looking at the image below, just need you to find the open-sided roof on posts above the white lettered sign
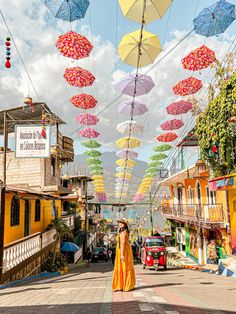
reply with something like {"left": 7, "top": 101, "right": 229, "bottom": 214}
{"left": 0, "top": 103, "right": 65, "bottom": 135}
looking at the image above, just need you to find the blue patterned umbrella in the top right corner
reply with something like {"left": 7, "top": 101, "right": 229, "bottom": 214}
{"left": 193, "top": 0, "right": 235, "bottom": 37}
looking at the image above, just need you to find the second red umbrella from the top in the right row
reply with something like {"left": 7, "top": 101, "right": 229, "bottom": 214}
{"left": 173, "top": 76, "right": 202, "bottom": 96}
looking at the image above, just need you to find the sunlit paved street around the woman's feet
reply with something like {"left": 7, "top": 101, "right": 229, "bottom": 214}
{"left": 0, "top": 262, "right": 236, "bottom": 314}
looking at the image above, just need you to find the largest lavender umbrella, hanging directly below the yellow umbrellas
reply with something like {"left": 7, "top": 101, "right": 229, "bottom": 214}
{"left": 116, "top": 74, "right": 155, "bottom": 96}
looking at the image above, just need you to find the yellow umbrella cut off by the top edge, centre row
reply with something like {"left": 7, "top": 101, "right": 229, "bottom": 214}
{"left": 119, "top": 0, "right": 173, "bottom": 23}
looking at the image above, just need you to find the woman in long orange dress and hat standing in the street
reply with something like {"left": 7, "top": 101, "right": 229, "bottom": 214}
{"left": 112, "top": 218, "right": 135, "bottom": 291}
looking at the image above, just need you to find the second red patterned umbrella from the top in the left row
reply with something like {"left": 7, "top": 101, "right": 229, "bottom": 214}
{"left": 64, "top": 67, "right": 95, "bottom": 87}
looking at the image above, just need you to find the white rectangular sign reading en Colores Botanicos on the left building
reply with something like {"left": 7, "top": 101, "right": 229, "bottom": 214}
{"left": 15, "top": 125, "right": 50, "bottom": 158}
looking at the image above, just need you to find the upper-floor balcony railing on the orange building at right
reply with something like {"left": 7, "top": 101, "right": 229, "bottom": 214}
{"left": 159, "top": 204, "right": 224, "bottom": 225}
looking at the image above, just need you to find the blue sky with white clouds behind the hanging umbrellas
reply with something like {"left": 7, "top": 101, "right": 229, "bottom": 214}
{"left": 0, "top": 0, "right": 236, "bottom": 169}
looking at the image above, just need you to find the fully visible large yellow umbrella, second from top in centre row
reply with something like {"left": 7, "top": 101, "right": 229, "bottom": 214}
{"left": 117, "top": 30, "right": 161, "bottom": 67}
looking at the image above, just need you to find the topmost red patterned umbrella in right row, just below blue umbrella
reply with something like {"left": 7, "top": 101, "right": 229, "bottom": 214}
{"left": 181, "top": 45, "right": 216, "bottom": 71}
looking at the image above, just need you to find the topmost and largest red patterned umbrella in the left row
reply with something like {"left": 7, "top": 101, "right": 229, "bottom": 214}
{"left": 56, "top": 31, "right": 93, "bottom": 60}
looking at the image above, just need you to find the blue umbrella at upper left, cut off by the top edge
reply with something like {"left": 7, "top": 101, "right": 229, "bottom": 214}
{"left": 44, "top": 0, "right": 89, "bottom": 22}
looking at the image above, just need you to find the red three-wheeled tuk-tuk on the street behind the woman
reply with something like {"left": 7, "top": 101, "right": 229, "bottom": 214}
{"left": 141, "top": 236, "right": 167, "bottom": 270}
